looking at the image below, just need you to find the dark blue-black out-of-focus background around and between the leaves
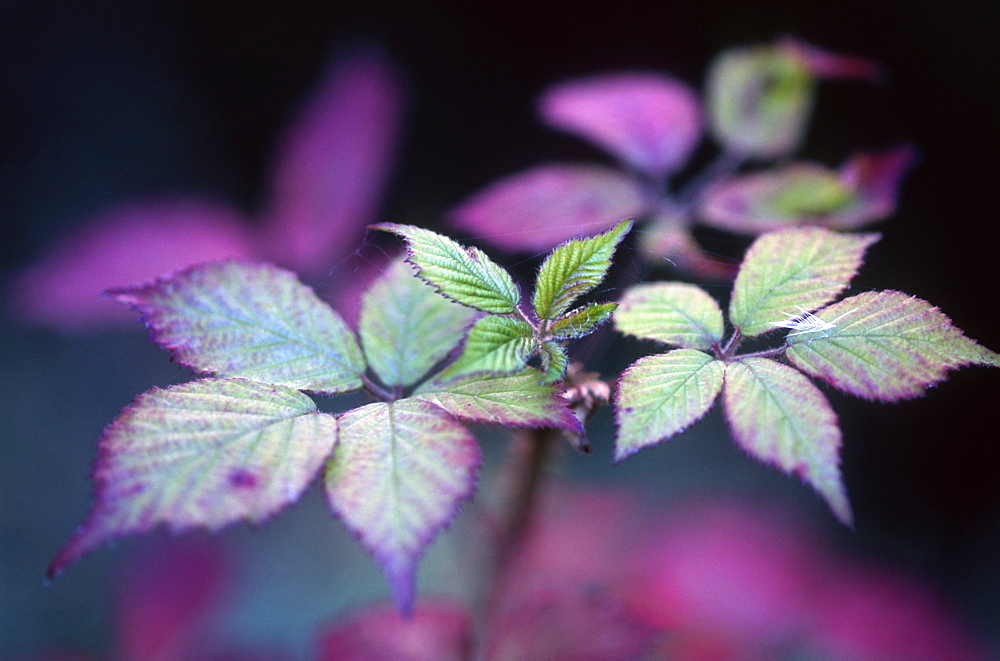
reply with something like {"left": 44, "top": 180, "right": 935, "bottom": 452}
{"left": 0, "top": 0, "right": 1000, "bottom": 658}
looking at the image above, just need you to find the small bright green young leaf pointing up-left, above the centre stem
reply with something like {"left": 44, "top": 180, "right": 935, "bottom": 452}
{"left": 372, "top": 223, "right": 521, "bottom": 314}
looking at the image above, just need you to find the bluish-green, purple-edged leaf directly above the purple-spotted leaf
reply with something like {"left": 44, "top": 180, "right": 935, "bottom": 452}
{"left": 110, "top": 261, "right": 365, "bottom": 394}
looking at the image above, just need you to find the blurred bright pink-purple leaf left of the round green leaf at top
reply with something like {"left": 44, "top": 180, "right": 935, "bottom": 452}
{"left": 538, "top": 72, "right": 702, "bottom": 177}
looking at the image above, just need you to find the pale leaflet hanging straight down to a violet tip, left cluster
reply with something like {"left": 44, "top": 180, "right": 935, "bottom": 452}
{"left": 325, "top": 399, "right": 479, "bottom": 613}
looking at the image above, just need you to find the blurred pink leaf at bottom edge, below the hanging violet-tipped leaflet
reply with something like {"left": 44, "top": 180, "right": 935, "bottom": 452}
{"left": 317, "top": 599, "right": 472, "bottom": 661}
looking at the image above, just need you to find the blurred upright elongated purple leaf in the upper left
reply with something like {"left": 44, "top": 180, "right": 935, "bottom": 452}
{"left": 260, "top": 50, "right": 403, "bottom": 273}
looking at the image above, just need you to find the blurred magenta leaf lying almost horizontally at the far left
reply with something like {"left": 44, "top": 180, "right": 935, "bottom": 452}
{"left": 10, "top": 199, "right": 252, "bottom": 331}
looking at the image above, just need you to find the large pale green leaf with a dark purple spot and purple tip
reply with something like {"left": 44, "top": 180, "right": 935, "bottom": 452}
{"left": 49, "top": 379, "right": 337, "bottom": 576}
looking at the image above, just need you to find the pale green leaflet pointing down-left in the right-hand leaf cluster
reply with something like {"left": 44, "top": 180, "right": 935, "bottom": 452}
{"left": 615, "top": 349, "right": 725, "bottom": 462}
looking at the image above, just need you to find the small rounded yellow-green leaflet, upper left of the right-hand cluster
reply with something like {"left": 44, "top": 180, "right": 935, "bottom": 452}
{"left": 614, "top": 282, "right": 723, "bottom": 351}
